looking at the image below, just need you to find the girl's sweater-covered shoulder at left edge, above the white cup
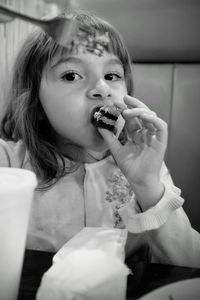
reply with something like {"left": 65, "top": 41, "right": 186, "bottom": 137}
{"left": 0, "top": 139, "right": 27, "bottom": 168}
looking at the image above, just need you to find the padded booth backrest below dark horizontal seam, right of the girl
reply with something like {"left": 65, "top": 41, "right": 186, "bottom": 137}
{"left": 132, "top": 62, "right": 200, "bottom": 232}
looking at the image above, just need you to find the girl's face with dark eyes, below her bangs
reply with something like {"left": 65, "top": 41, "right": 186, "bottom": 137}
{"left": 39, "top": 50, "right": 127, "bottom": 152}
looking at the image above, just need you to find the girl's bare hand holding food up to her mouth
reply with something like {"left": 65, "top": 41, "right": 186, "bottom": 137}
{"left": 99, "top": 96, "right": 168, "bottom": 210}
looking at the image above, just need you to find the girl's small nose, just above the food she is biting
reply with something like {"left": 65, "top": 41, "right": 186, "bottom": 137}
{"left": 88, "top": 79, "right": 111, "bottom": 100}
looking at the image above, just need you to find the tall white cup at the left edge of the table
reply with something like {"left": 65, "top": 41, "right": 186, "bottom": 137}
{"left": 0, "top": 168, "right": 37, "bottom": 300}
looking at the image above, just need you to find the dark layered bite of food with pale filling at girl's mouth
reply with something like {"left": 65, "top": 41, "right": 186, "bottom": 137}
{"left": 91, "top": 105, "right": 123, "bottom": 133}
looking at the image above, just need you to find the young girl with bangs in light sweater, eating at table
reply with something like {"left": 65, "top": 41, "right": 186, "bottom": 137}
{"left": 0, "top": 13, "right": 200, "bottom": 266}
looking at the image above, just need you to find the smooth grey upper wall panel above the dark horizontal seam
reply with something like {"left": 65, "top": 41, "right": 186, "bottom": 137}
{"left": 73, "top": 0, "right": 200, "bottom": 63}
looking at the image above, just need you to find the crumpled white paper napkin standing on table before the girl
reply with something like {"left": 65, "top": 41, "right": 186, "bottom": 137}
{"left": 37, "top": 228, "right": 130, "bottom": 300}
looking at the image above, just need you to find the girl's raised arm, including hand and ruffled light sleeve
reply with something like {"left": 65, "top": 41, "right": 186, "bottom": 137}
{"left": 99, "top": 96, "right": 200, "bottom": 267}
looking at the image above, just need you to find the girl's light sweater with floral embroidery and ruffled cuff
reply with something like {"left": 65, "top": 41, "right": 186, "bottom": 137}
{"left": 0, "top": 140, "right": 200, "bottom": 267}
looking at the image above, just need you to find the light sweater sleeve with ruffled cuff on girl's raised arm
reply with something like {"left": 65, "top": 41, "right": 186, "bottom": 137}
{"left": 119, "top": 165, "right": 200, "bottom": 267}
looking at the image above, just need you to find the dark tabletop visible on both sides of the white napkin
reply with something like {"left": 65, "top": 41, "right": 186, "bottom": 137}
{"left": 18, "top": 250, "right": 200, "bottom": 300}
